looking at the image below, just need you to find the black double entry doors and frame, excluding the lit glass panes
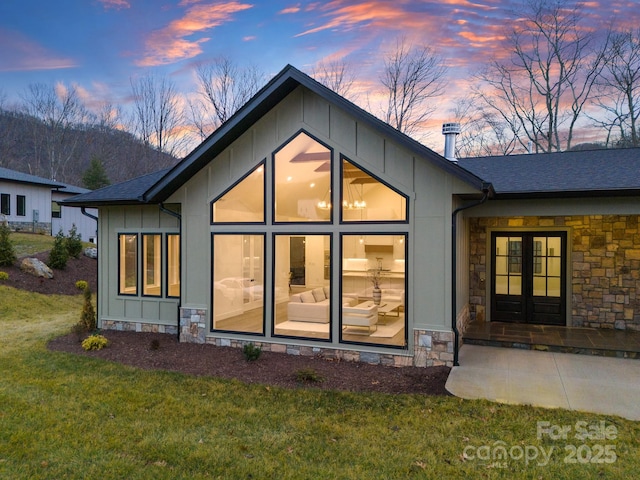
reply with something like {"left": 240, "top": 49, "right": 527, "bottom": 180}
{"left": 487, "top": 230, "right": 569, "bottom": 326}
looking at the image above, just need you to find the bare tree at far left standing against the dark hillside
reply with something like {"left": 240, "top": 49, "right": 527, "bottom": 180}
{"left": 22, "top": 83, "right": 87, "bottom": 181}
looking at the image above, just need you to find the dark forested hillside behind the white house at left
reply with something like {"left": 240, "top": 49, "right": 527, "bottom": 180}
{"left": 0, "top": 110, "right": 178, "bottom": 186}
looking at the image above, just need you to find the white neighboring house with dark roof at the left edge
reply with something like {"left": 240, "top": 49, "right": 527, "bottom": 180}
{"left": 0, "top": 167, "right": 97, "bottom": 242}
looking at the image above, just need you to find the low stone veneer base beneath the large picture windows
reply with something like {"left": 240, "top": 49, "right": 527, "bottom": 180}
{"left": 180, "top": 308, "right": 454, "bottom": 367}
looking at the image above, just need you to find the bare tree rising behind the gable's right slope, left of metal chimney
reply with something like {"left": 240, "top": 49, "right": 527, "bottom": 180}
{"left": 380, "top": 38, "right": 446, "bottom": 135}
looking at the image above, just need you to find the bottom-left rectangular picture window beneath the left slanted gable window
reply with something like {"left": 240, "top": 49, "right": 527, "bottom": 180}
{"left": 213, "top": 234, "right": 264, "bottom": 334}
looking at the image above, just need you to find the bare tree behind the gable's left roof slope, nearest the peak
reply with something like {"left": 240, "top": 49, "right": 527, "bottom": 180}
{"left": 189, "top": 57, "right": 265, "bottom": 140}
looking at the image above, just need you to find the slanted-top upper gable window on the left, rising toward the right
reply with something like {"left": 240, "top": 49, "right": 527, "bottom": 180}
{"left": 211, "top": 163, "right": 264, "bottom": 223}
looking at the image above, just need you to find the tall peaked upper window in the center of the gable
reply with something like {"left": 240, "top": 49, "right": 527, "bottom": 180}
{"left": 274, "top": 132, "right": 332, "bottom": 222}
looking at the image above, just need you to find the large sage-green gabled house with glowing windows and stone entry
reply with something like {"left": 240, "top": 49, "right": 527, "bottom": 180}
{"left": 64, "top": 66, "right": 640, "bottom": 366}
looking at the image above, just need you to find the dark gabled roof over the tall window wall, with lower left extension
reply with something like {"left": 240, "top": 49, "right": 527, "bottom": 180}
{"left": 85, "top": 65, "right": 486, "bottom": 205}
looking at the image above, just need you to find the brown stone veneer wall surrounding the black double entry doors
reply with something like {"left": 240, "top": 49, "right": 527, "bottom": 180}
{"left": 469, "top": 215, "right": 640, "bottom": 331}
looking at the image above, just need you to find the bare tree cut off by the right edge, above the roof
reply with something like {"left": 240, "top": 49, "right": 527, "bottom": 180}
{"left": 594, "top": 29, "right": 640, "bottom": 147}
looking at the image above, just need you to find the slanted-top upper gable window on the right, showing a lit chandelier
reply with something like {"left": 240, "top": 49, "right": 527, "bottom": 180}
{"left": 341, "top": 158, "right": 407, "bottom": 222}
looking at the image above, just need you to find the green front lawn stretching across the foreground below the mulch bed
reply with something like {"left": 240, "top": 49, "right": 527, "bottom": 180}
{"left": 0, "top": 286, "right": 640, "bottom": 479}
